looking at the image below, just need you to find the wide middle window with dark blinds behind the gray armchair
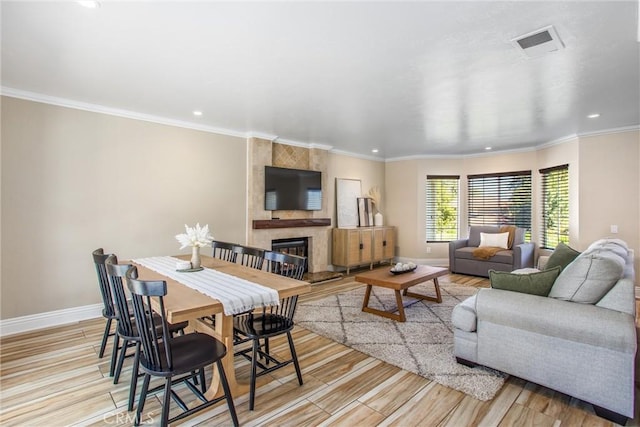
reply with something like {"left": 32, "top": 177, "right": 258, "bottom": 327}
{"left": 467, "top": 171, "right": 531, "bottom": 237}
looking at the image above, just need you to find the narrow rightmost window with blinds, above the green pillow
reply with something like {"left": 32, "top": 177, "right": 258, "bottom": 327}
{"left": 540, "top": 165, "right": 569, "bottom": 249}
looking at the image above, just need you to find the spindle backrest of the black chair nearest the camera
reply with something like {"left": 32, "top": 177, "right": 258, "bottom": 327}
{"left": 126, "top": 266, "right": 173, "bottom": 372}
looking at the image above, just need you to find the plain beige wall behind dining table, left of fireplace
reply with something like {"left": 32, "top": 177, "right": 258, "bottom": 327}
{"left": 1, "top": 97, "right": 247, "bottom": 319}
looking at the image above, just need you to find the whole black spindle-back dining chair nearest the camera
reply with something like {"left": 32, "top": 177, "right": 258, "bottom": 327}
{"left": 126, "top": 266, "right": 238, "bottom": 426}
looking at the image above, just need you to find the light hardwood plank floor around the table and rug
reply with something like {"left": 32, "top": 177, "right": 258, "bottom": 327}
{"left": 0, "top": 272, "right": 638, "bottom": 427}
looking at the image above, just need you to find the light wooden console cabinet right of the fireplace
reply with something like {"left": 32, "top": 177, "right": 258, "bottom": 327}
{"left": 331, "top": 227, "right": 396, "bottom": 274}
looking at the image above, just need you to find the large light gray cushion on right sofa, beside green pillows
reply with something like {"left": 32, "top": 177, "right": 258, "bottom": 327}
{"left": 549, "top": 251, "right": 625, "bottom": 304}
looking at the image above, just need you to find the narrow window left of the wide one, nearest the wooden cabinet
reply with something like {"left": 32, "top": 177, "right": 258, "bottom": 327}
{"left": 426, "top": 175, "right": 460, "bottom": 242}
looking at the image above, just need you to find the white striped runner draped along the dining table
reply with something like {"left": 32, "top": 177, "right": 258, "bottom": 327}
{"left": 133, "top": 256, "right": 280, "bottom": 316}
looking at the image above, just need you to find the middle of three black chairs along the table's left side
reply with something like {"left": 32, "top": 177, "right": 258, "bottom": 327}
{"left": 105, "top": 255, "right": 189, "bottom": 411}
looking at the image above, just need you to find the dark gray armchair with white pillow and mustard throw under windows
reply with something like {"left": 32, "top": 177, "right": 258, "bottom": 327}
{"left": 449, "top": 226, "right": 535, "bottom": 277}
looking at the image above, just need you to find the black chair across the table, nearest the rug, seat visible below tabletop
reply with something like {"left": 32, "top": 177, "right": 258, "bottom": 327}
{"left": 234, "top": 251, "right": 306, "bottom": 410}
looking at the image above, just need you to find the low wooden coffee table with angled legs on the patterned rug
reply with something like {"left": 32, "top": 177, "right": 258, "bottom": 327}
{"left": 355, "top": 265, "right": 449, "bottom": 322}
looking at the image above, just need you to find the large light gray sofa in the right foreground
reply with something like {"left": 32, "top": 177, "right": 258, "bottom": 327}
{"left": 452, "top": 240, "right": 637, "bottom": 425}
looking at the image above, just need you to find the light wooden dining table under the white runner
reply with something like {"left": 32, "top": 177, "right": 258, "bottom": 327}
{"left": 132, "top": 255, "right": 311, "bottom": 399}
